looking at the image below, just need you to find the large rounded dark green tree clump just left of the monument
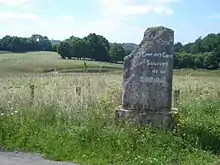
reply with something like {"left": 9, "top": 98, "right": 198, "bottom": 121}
{"left": 53, "top": 33, "right": 128, "bottom": 62}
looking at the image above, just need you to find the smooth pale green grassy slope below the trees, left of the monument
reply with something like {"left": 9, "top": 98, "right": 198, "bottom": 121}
{"left": 0, "top": 52, "right": 122, "bottom": 74}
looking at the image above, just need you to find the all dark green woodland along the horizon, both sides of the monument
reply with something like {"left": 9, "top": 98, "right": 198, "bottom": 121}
{"left": 0, "top": 33, "right": 220, "bottom": 69}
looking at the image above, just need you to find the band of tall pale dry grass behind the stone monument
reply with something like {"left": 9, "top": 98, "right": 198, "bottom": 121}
{"left": 0, "top": 73, "right": 220, "bottom": 106}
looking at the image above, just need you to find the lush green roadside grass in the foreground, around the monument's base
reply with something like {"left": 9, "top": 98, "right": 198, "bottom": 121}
{"left": 0, "top": 98, "right": 220, "bottom": 165}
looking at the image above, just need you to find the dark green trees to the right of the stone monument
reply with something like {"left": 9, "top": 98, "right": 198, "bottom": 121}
{"left": 174, "top": 33, "right": 220, "bottom": 69}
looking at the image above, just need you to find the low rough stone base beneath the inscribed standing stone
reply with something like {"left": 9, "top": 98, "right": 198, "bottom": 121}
{"left": 115, "top": 109, "right": 173, "bottom": 129}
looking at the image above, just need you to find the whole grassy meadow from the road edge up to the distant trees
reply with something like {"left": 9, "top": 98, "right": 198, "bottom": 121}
{"left": 0, "top": 52, "right": 220, "bottom": 165}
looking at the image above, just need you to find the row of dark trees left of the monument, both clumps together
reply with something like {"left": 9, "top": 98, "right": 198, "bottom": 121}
{"left": 0, "top": 33, "right": 127, "bottom": 62}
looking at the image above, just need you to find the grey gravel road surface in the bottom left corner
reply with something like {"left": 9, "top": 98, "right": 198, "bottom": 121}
{"left": 0, "top": 152, "right": 79, "bottom": 165}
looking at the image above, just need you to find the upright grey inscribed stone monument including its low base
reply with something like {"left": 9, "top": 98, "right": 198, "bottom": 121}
{"left": 116, "top": 27, "right": 174, "bottom": 127}
